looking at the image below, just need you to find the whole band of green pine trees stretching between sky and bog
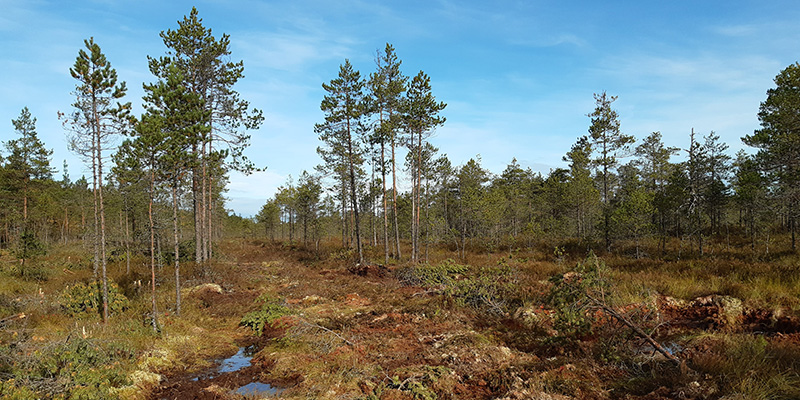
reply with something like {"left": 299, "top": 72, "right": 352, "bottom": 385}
{"left": 0, "top": 0, "right": 800, "bottom": 327}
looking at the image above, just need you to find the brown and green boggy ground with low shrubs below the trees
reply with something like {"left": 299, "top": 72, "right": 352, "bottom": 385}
{"left": 0, "top": 240, "right": 800, "bottom": 399}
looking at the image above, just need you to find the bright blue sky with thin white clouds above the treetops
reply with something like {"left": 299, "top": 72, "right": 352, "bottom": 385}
{"left": 0, "top": 0, "right": 800, "bottom": 215}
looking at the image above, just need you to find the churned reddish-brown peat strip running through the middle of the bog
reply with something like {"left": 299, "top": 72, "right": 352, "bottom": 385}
{"left": 150, "top": 242, "right": 800, "bottom": 400}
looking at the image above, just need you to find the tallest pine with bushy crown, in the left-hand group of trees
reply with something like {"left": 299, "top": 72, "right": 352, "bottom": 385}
{"left": 156, "top": 7, "right": 264, "bottom": 262}
